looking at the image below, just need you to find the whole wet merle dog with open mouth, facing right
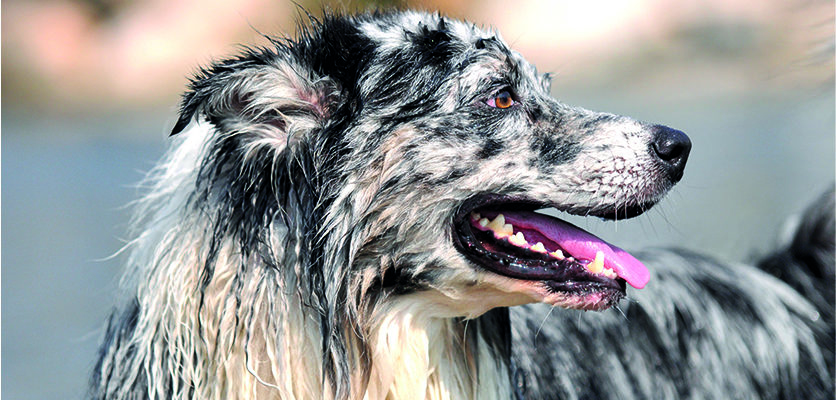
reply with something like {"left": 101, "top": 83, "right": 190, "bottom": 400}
{"left": 90, "top": 11, "right": 834, "bottom": 399}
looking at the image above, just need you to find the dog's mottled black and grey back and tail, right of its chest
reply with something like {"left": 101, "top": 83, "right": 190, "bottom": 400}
{"left": 511, "top": 189, "right": 836, "bottom": 400}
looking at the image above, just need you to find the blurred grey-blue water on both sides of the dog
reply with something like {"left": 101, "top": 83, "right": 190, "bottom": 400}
{"left": 2, "top": 86, "right": 835, "bottom": 399}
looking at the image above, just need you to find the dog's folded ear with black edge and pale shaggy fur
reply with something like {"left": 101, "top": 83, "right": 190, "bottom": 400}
{"left": 171, "top": 49, "right": 338, "bottom": 138}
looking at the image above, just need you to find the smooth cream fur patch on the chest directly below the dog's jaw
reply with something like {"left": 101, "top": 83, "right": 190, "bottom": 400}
{"left": 358, "top": 299, "right": 511, "bottom": 400}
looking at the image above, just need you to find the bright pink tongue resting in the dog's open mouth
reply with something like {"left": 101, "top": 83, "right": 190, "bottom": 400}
{"left": 496, "top": 211, "right": 650, "bottom": 289}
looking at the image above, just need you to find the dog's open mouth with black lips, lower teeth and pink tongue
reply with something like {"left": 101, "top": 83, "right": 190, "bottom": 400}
{"left": 454, "top": 199, "right": 649, "bottom": 305}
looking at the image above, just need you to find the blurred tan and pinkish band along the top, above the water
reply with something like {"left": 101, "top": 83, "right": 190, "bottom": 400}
{"left": 2, "top": 0, "right": 834, "bottom": 111}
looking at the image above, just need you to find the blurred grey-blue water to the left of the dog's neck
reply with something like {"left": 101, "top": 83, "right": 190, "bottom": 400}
{"left": 2, "top": 113, "right": 165, "bottom": 399}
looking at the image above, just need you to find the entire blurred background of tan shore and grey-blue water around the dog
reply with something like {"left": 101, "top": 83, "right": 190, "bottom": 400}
{"left": 2, "top": 0, "right": 836, "bottom": 399}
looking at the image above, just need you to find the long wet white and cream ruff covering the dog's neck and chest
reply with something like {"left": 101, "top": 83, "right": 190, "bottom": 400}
{"left": 93, "top": 125, "right": 511, "bottom": 399}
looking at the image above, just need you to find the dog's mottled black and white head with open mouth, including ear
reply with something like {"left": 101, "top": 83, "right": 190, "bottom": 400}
{"left": 174, "top": 12, "right": 691, "bottom": 317}
